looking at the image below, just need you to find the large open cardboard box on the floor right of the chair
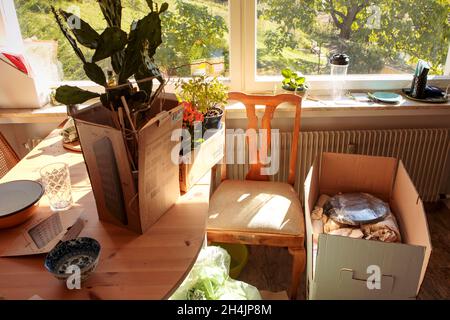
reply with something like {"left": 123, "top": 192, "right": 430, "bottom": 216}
{"left": 305, "top": 153, "right": 431, "bottom": 299}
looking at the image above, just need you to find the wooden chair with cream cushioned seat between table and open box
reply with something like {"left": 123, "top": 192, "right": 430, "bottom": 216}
{"left": 207, "top": 92, "right": 306, "bottom": 299}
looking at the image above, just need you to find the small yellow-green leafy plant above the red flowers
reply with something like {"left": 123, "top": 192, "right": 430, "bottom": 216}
{"left": 176, "top": 76, "right": 228, "bottom": 114}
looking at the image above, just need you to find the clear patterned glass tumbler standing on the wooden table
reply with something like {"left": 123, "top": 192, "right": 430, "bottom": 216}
{"left": 40, "top": 162, "right": 73, "bottom": 211}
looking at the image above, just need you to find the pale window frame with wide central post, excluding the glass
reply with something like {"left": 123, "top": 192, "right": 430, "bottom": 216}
{"left": 0, "top": 0, "right": 450, "bottom": 94}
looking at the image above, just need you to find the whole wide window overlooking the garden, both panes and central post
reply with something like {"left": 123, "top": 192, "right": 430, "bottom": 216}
{"left": 0, "top": 0, "right": 450, "bottom": 92}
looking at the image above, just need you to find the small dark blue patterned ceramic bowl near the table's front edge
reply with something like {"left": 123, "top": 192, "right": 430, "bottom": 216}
{"left": 44, "top": 237, "right": 100, "bottom": 281}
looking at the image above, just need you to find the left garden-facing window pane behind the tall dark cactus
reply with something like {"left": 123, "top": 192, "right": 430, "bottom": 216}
{"left": 14, "top": 0, "right": 229, "bottom": 80}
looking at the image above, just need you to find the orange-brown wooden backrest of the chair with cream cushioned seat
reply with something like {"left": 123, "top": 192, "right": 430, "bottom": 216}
{"left": 228, "top": 92, "right": 302, "bottom": 185}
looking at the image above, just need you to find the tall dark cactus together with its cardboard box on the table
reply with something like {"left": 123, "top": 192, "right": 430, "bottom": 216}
{"left": 52, "top": 0, "right": 183, "bottom": 233}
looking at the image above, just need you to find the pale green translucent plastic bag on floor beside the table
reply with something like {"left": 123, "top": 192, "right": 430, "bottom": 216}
{"left": 169, "top": 246, "right": 261, "bottom": 300}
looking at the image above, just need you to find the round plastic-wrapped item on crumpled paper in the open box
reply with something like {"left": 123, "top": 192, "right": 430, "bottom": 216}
{"left": 324, "top": 193, "right": 390, "bottom": 226}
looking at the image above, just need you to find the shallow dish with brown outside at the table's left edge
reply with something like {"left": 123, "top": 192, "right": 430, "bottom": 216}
{"left": 0, "top": 180, "right": 44, "bottom": 229}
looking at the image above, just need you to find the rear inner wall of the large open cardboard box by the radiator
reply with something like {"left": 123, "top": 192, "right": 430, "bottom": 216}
{"left": 320, "top": 153, "right": 397, "bottom": 201}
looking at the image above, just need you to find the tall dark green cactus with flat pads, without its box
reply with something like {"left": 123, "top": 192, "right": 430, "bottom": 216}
{"left": 51, "top": 0, "right": 168, "bottom": 107}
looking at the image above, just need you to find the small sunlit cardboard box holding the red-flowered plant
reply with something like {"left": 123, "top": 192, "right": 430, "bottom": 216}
{"left": 179, "top": 122, "right": 225, "bottom": 192}
